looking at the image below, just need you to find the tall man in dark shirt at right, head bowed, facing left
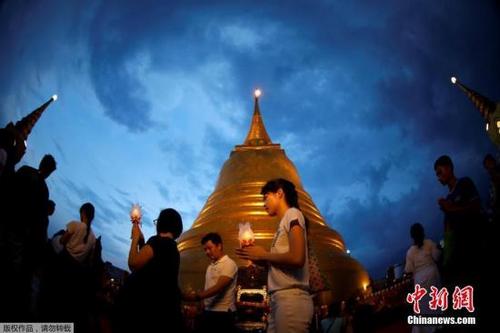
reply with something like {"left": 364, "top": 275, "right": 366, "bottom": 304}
{"left": 434, "top": 155, "right": 483, "bottom": 290}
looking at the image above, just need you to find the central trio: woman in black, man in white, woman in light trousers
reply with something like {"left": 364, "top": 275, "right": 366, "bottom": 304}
{"left": 113, "top": 179, "right": 313, "bottom": 332}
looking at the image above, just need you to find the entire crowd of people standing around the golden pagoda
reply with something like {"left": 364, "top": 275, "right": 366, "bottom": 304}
{"left": 0, "top": 128, "right": 500, "bottom": 333}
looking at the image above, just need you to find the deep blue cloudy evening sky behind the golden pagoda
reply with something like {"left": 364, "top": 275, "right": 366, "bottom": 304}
{"left": 0, "top": 0, "right": 500, "bottom": 278}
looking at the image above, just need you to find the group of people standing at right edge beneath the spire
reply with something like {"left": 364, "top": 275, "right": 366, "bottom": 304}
{"left": 405, "top": 154, "right": 500, "bottom": 332}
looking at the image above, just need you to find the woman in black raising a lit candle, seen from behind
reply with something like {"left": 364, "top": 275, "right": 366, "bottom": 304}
{"left": 114, "top": 208, "right": 183, "bottom": 332}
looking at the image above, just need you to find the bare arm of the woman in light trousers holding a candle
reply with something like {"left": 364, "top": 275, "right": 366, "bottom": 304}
{"left": 236, "top": 220, "right": 306, "bottom": 268}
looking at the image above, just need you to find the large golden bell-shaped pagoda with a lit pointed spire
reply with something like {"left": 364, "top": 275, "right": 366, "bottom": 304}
{"left": 178, "top": 90, "right": 370, "bottom": 303}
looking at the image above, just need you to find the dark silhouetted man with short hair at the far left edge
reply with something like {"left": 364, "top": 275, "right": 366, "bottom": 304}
{"left": 0, "top": 155, "right": 56, "bottom": 320}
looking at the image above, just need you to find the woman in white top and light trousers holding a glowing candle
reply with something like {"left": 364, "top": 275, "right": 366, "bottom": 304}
{"left": 236, "top": 178, "right": 314, "bottom": 333}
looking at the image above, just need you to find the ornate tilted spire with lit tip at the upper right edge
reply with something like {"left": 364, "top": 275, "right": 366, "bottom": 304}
{"left": 451, "top": 76, "right": 500, "bottom": 147}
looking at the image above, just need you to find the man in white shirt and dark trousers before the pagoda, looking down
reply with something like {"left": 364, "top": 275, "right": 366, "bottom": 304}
{"left": 187, "top": 232, "right": 238, "bottom": 332}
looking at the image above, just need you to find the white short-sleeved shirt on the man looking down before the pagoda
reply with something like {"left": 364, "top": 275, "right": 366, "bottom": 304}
{"left": 204, "top": 254, "right": 238, "bottom": 312}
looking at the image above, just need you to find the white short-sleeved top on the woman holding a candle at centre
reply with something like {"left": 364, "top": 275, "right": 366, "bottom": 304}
{"left": 267, "top": 208, "right": 309, "bottom": 292}
